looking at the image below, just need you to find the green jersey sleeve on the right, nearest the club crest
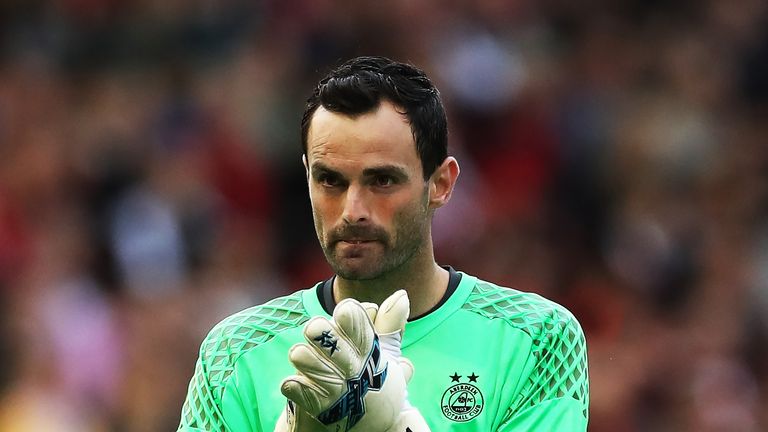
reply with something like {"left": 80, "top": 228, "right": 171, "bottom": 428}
{"left": 497, "top": 308, "right": 589, "bottom": 432}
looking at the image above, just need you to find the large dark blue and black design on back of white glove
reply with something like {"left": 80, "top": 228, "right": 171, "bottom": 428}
{"left": 317, "top": 336, "right": 387, "bottom": 430}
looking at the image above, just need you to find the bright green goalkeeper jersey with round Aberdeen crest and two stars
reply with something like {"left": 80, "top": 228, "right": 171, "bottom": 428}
{"left": 179, "top": 269, "right": 589, "bottom": 432}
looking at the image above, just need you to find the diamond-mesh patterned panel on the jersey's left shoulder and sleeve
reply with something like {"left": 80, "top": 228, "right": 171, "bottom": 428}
{"left": 179, "top": 292, "right": 309, "bottom": 432}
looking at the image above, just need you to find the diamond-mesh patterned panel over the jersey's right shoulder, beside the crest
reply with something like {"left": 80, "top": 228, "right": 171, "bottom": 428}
{"left": 463, "top": 281, "right": 589, "bottom": 418}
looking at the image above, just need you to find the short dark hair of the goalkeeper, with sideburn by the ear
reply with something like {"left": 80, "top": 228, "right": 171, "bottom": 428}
{"left": 301, "top": 57, "right": 448, "bottom": 179}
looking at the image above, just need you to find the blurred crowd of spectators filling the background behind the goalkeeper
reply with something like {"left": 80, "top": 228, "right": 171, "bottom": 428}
{"left": 0, "top": 0, "right": 768, "bottom": 432}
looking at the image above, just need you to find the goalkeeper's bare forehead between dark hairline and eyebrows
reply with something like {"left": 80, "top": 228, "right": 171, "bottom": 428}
{"left": 307, "top": 101, "right": 421, "bottom": 169}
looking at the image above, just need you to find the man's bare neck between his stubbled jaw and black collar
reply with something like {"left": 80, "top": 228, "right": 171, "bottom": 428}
{"left": 333, "top": 243, "right": 448, "bottom": 317}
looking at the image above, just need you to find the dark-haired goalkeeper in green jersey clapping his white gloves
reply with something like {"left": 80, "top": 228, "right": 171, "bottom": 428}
{"left": 179, "top": 57, "right": 589, "bottom": 432}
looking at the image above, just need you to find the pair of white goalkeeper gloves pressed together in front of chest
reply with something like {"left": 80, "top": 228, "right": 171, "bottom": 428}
{"left": 275, "top": 290, "right": 429, "bottom": 432}
